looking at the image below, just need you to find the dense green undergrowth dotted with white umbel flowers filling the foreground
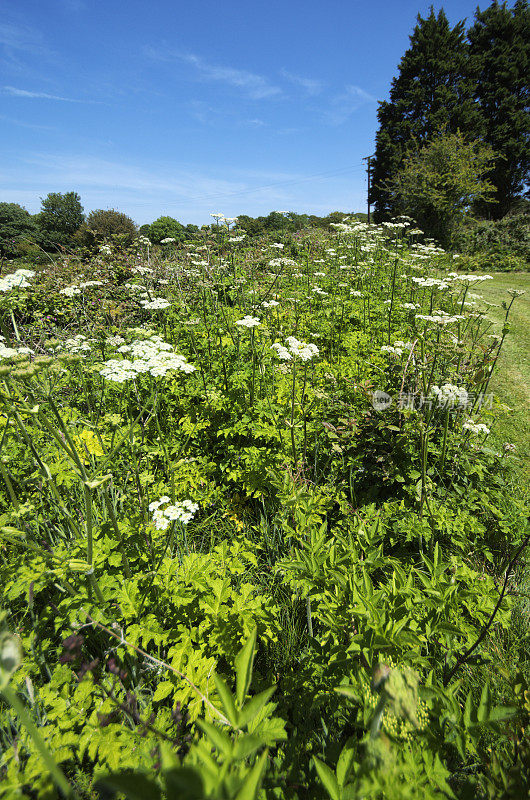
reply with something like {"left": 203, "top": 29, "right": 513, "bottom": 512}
{"left": 0, "top": 220, "right": 530, "bottom": 800}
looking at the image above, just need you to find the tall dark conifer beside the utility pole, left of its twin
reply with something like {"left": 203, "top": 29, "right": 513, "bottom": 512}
{"left": 370, "top": 6, "right": 482, "bottom": 220}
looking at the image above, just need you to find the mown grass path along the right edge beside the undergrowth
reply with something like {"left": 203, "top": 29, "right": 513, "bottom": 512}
{"left": 475, "top": 272, "right": 530, "bottom": 476}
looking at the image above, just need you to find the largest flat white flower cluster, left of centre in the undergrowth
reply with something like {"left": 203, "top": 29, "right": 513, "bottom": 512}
{"left": 99, "top": 336, "right": 195, "bottom": 383}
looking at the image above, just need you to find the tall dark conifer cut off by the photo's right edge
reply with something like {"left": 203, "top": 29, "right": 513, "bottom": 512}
{"left": 468, "top": 0, "right": 530, "bottom": 219}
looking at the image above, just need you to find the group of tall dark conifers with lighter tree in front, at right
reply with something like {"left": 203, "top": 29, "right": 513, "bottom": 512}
{"left": 369, "top": 0, "right": 530, "bottom": 236}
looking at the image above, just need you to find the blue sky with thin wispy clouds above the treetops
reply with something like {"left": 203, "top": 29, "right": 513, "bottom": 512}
{"left": 0, "top": 0, "right": 500, "bottom": 224}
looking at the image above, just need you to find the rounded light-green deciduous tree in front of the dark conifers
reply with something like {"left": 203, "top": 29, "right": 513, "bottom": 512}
{"left": 390, "top": 132, "right": 494, "bottom": 246}
